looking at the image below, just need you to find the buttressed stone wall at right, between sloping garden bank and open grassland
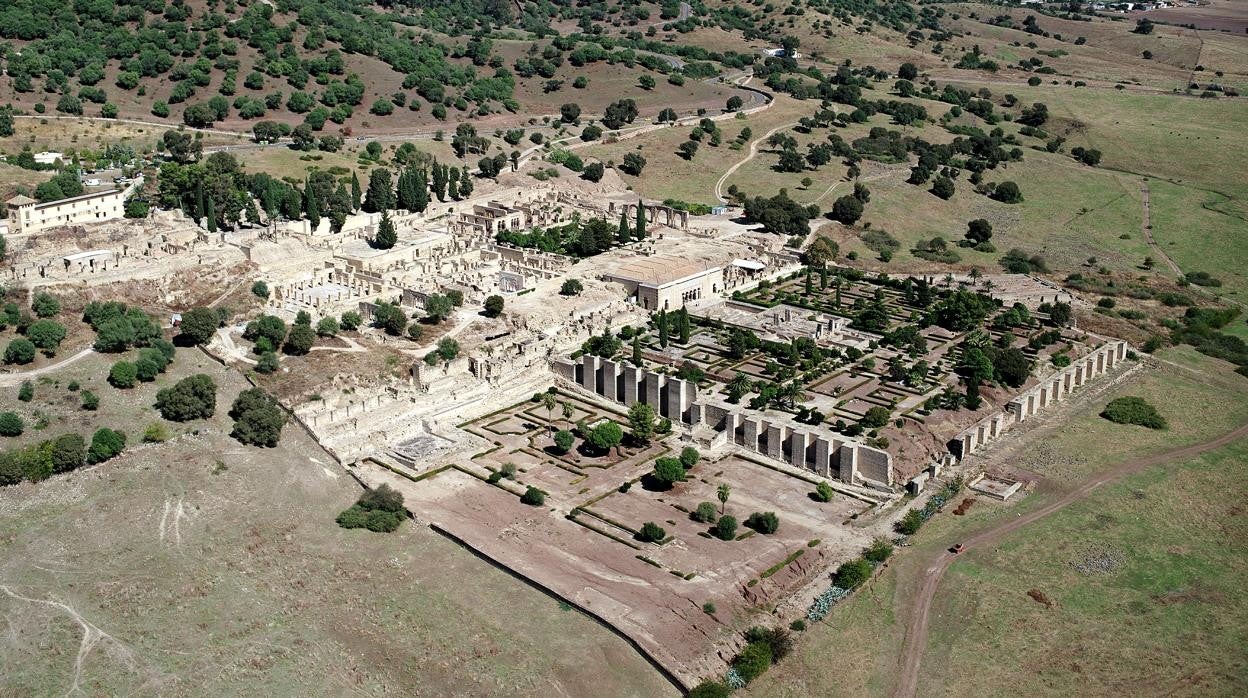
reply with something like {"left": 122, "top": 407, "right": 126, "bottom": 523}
{"left": 948, "top": 340, "right": 1128, "bottom": 458}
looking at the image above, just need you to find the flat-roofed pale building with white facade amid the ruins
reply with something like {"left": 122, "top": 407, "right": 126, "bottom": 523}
{"left": 603, "top": 256, "right": 724, "bottom": 311}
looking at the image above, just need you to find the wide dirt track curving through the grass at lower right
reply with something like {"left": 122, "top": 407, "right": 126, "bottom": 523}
{"left": 895, "top": 425, "right": 1248, "bottom": 698}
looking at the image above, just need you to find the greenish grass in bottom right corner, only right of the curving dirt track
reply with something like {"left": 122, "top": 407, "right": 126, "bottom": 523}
{"left": 920, "top": 441, "right": 1248, "bottom": 696}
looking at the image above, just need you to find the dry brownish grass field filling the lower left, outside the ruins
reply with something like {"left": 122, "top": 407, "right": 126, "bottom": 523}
{"left": 0, "top": 350, "right": 673, "bottom": 697}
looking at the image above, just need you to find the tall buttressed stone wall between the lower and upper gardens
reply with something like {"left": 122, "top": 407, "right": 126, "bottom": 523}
{"left": 553, "top": 355, "right": 894, "bottom": 487}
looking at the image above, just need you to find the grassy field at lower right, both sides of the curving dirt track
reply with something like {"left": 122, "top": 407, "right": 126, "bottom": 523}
{"left": 749, "top": 347, "right": 1248, "bottom": 696}
